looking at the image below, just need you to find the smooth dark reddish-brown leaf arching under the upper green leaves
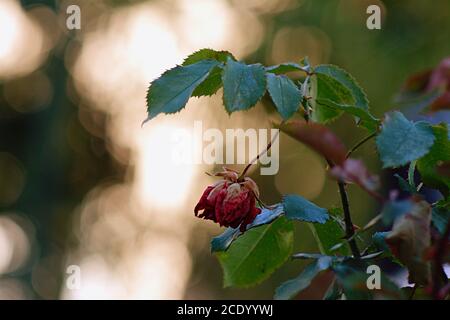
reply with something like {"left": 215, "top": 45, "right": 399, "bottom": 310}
{"left": 278, "top": 121, "right": 347, "bottom": 165}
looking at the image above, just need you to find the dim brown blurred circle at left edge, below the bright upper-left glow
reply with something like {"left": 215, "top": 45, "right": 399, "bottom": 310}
{"left": 3, "top": 71, "right": 53, "bottom": 113}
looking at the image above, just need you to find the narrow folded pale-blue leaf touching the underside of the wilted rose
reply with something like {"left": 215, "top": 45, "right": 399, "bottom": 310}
{"left": 211, "top": 203, "right": 284, "bottom": 252}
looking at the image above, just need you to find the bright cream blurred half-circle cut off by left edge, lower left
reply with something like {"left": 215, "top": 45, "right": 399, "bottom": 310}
{"left": 0, "top": 215, "right": 30, "bottom": 275}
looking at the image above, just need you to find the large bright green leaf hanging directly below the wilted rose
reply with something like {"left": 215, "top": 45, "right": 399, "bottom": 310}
{"left": 217, "top": 217, "right": 294, "bottom": 287}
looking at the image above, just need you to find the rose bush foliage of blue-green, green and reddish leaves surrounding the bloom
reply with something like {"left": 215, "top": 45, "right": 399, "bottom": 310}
{"left": 147, "top": 49, "right": 450, "bottom": 299}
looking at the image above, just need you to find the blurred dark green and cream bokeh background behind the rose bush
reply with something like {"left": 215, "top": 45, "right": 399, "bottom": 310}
{"left": 0, "top": 0, "right": 450, "bottom": 299}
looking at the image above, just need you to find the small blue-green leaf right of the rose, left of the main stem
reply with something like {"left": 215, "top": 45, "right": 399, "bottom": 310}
{"left": 283, "top": 194, "right": 329, "bottom": 223}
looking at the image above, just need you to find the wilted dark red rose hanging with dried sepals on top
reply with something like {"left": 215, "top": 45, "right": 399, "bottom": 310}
{"left": 194, "top": 169, "right": 261, "bottom": 232}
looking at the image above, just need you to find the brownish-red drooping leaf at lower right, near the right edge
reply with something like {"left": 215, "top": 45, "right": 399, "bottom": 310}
{"left": 385, "top": 200, "right": 431, "bottom": 285}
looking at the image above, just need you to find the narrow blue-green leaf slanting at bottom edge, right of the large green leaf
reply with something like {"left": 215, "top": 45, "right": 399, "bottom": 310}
{"left": 274, "top": 256, "right": 333, "bottom": 300}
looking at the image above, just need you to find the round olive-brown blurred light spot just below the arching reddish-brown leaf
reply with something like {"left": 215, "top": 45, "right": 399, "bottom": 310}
{"left": 275, "top": 135, "right": 326, "bottom": 199}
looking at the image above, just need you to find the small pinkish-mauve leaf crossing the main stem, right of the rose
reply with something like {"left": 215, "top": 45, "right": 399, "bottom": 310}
{"left": 331, "top": 159, "right": 379, "bottom": 191}
